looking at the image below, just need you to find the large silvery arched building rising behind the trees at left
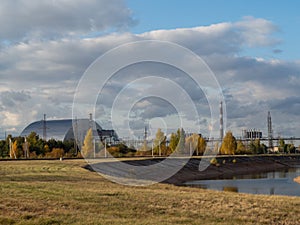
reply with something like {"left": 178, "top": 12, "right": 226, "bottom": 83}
{"left": 20, "top": 117, "right": 119, "bottom": 144}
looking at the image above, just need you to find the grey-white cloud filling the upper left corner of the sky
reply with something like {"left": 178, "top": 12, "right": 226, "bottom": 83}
{"left": 0, "top": 0, "right": 135, "bottom": 42}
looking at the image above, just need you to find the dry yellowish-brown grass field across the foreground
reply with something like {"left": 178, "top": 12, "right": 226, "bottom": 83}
{"left": 0, "top": 160, "right": 300, "bottom": 225}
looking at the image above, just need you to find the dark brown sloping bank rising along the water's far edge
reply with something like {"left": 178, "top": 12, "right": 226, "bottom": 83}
{"left": 164, "top": 156, "right": 300, "bottom": 185}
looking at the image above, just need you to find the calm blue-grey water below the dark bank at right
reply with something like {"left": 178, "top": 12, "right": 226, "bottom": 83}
{"left": 185, "top": 165, "right": 300, "bottom": 196}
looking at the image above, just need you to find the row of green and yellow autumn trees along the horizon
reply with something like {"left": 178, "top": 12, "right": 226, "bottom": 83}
{"left": 0, "top": 128, "right": 296, "bottom": 159}
